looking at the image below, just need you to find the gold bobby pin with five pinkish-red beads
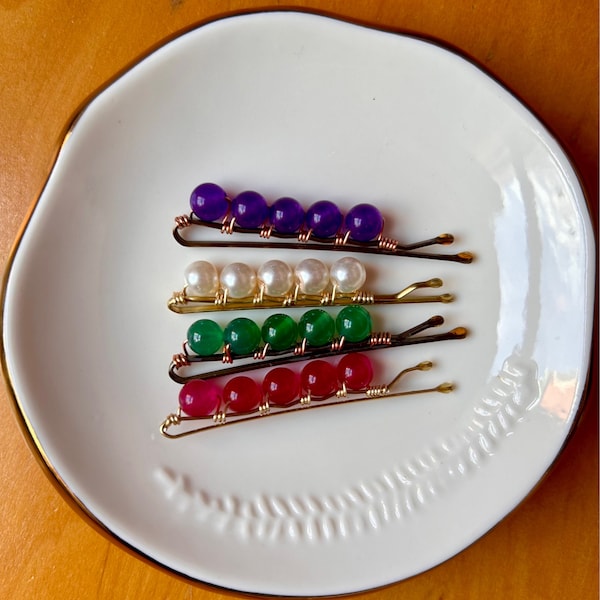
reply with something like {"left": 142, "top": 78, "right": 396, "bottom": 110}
{"left": 160, "top": 353, "right": 454, "bottom": 439}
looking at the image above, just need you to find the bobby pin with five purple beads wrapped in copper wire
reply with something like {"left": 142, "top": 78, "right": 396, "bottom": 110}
{"left": 173, "top": 183, "right": 473, "bottom": 263}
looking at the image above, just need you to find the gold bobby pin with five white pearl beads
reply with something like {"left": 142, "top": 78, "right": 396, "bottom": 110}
{"left": 167, "top": 256, "right": 454, "bottom": 313}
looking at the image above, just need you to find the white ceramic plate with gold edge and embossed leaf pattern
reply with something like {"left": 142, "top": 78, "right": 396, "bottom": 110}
{"left": 3, "top": 12, "right": 594, "bottom": 595}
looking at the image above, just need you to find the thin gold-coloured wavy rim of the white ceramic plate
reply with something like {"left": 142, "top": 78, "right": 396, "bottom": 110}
{"left": 0, "top": 7, "right": 598, "bottom": 598}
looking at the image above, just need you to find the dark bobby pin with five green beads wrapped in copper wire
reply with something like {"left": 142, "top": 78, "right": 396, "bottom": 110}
{"left": 169, "top": 306, "right": 467, "bottom": 383}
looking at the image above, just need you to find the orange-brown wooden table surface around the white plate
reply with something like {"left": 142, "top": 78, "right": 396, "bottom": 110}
{"left": 0, "top": 0, "right": 598, "bottom": 600}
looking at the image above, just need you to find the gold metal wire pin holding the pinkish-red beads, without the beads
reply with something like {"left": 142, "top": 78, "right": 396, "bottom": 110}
{"left": 160, "top": 361, "right": 455, "bottom": 439}
